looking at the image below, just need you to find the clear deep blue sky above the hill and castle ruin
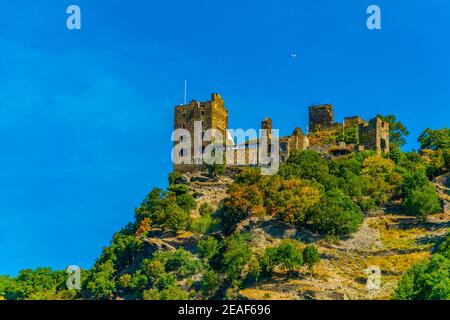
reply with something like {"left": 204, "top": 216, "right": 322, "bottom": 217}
{"left": 0, "top": 0, "right": 450, "bottom": 275}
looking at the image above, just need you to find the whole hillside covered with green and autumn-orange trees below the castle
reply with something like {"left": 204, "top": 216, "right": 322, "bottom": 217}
{"left": 0, "top": 140, "right": 450, "bottom": 300}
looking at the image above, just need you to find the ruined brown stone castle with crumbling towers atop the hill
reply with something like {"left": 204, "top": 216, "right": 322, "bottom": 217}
{"left": 173, "top": 93, "right": 389, "bottom": 171}
